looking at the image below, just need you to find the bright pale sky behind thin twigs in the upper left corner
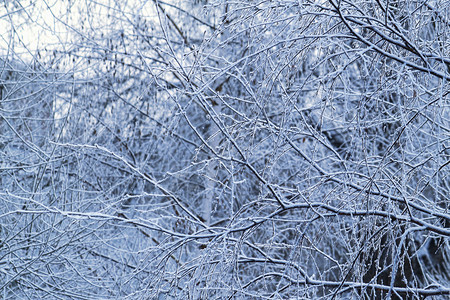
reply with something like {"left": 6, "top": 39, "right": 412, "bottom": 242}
{"left": 0, "top": 0, "right": 162, "bottom": 59}
